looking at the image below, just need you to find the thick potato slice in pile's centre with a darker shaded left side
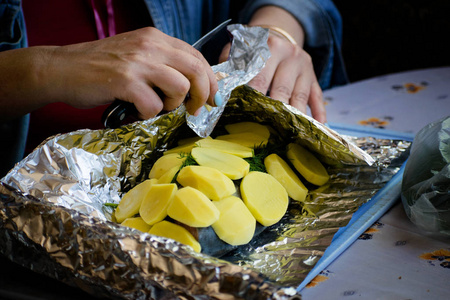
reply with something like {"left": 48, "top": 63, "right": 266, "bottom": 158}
{"left": 177, "top": 166, "right": 236, "bottom": 201}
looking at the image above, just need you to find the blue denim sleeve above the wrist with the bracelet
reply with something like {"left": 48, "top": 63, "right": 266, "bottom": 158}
{"left": 240, "top": 0, "right": 348, "bottom": 89}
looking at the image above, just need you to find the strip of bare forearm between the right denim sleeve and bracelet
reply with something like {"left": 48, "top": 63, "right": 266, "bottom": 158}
{"left": 248, "top": 6, "right": 305, "bottom": 47}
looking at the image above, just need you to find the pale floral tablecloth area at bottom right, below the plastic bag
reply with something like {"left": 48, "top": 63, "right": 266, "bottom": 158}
{"left": 302, "top": 203, "right": 450, "bottom": 300}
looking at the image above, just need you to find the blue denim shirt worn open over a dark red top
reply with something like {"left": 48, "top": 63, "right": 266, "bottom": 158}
{"left": 0, "top": 0, "right": 348, "bottom": 178}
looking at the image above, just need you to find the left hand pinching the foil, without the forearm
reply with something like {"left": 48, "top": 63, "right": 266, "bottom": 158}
{"left": 39, "top": 27, "right": 218, "bottom": 119}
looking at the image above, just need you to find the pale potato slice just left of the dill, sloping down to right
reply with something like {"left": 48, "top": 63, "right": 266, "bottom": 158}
{"left": 191, "top": 147, "right": 250, "bottom": 180}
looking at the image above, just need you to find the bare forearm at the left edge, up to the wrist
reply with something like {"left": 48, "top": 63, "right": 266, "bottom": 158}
{"left": 0, "top": 47, "right": 52, "bottom": 122}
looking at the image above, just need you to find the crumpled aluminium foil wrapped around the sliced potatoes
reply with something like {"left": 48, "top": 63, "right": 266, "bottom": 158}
{"left": 0, "top": 25, "right": 409, "bottom": 299}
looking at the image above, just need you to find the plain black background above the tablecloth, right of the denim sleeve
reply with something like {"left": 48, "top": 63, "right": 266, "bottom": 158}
{"left": 334, "top": 0, "right": 450, "bottom": 82}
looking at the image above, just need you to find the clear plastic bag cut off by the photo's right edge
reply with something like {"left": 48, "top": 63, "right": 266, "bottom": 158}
{"left": 401, "top": 116, "right": 450, "bottom": 236}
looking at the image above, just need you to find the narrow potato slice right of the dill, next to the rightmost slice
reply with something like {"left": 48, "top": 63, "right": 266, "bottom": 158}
{"left": 264, "top": 153, "right": 308, "bottom": 201}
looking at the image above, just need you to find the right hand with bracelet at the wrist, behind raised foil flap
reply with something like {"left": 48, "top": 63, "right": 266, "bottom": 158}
{"left": 216, "top": 5, "right": 326, "bottom": 123}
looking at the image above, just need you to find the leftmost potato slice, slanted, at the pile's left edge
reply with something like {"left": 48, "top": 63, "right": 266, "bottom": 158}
{"left": 114, "top": 179, "right": 156, "bottom": 223}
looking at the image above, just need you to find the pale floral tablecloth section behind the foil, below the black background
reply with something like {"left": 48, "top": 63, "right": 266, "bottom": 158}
{"left": 324, "top": 67, "right": 450, "bottom": 133}
